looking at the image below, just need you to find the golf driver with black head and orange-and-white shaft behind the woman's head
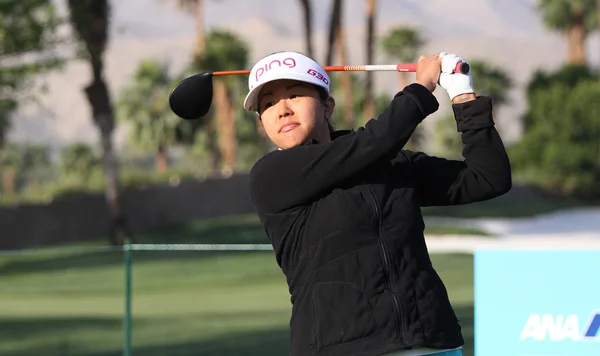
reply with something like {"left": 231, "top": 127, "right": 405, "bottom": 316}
{"left": 169, "top": 62, "right": 470, "bottom": 120}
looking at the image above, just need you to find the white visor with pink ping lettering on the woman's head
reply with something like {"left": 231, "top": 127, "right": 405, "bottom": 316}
{"left": 244, "top": 52, "right": 330, "bottom": 111}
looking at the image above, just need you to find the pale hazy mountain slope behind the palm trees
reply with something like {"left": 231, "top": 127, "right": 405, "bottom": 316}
{"left": 9, "top": 0, "right": 600, "bottom": 152}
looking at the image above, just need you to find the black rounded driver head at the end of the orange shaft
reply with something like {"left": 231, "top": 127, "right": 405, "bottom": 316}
{"left": 169, "top": 72, "right": 213, "bottom": 120}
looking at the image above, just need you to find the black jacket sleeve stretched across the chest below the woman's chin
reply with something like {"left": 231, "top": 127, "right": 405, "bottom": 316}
{"left": 249, "top": 84, "right": 439, "bottom": 213}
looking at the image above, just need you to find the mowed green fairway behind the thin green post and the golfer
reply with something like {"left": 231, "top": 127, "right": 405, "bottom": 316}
{"left": 0, "top": 214, "right": 473, "bottom": 356}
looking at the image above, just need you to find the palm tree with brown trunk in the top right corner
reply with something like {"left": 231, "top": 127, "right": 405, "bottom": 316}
{"left": 537, "top": 0, "right": 600, "bottom": 65}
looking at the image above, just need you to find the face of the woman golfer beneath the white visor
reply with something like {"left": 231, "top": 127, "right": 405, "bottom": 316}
{"left": 258, "top": 79, "right": 335, "bottom": 149}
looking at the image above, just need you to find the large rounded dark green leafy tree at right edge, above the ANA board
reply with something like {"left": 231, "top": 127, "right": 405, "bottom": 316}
{"left": 510, "top": 67, "right": 600, "bottom": 198}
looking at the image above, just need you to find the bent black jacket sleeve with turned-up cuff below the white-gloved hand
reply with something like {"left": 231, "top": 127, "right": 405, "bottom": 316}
{"left": 405, "top": 97, "right": 512, "bottom": 206}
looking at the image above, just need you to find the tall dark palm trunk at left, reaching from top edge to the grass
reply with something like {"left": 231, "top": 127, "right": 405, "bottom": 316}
{"left": 68, "top": 0, "right": 127, "bottom": 244}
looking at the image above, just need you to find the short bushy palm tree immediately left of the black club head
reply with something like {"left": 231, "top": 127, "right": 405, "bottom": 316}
{"left": 117, "top": 60, "right": 196, "bottom": 173}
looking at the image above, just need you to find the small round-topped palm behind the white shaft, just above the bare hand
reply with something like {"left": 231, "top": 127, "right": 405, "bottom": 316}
{"left": 381, "top": 26, "right": 425, "bottom": 90}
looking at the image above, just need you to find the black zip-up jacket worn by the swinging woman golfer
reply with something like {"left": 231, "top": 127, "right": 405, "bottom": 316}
{"left": 250, "top": 84, "right": 511, "bottom": 356}
